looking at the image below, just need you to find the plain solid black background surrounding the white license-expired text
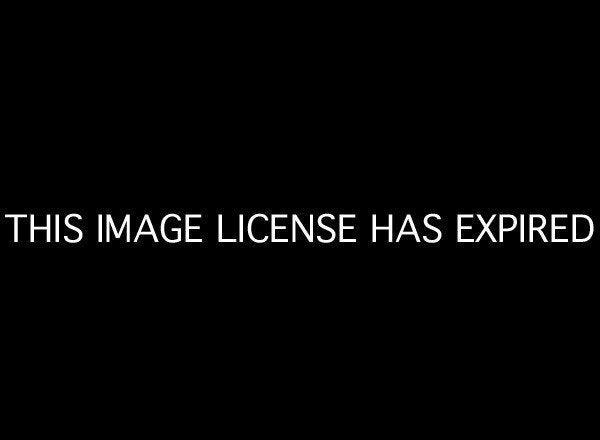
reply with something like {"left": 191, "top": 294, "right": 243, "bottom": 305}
{"left": 1, "top": 5, "right": 598, "bottom": 433}
